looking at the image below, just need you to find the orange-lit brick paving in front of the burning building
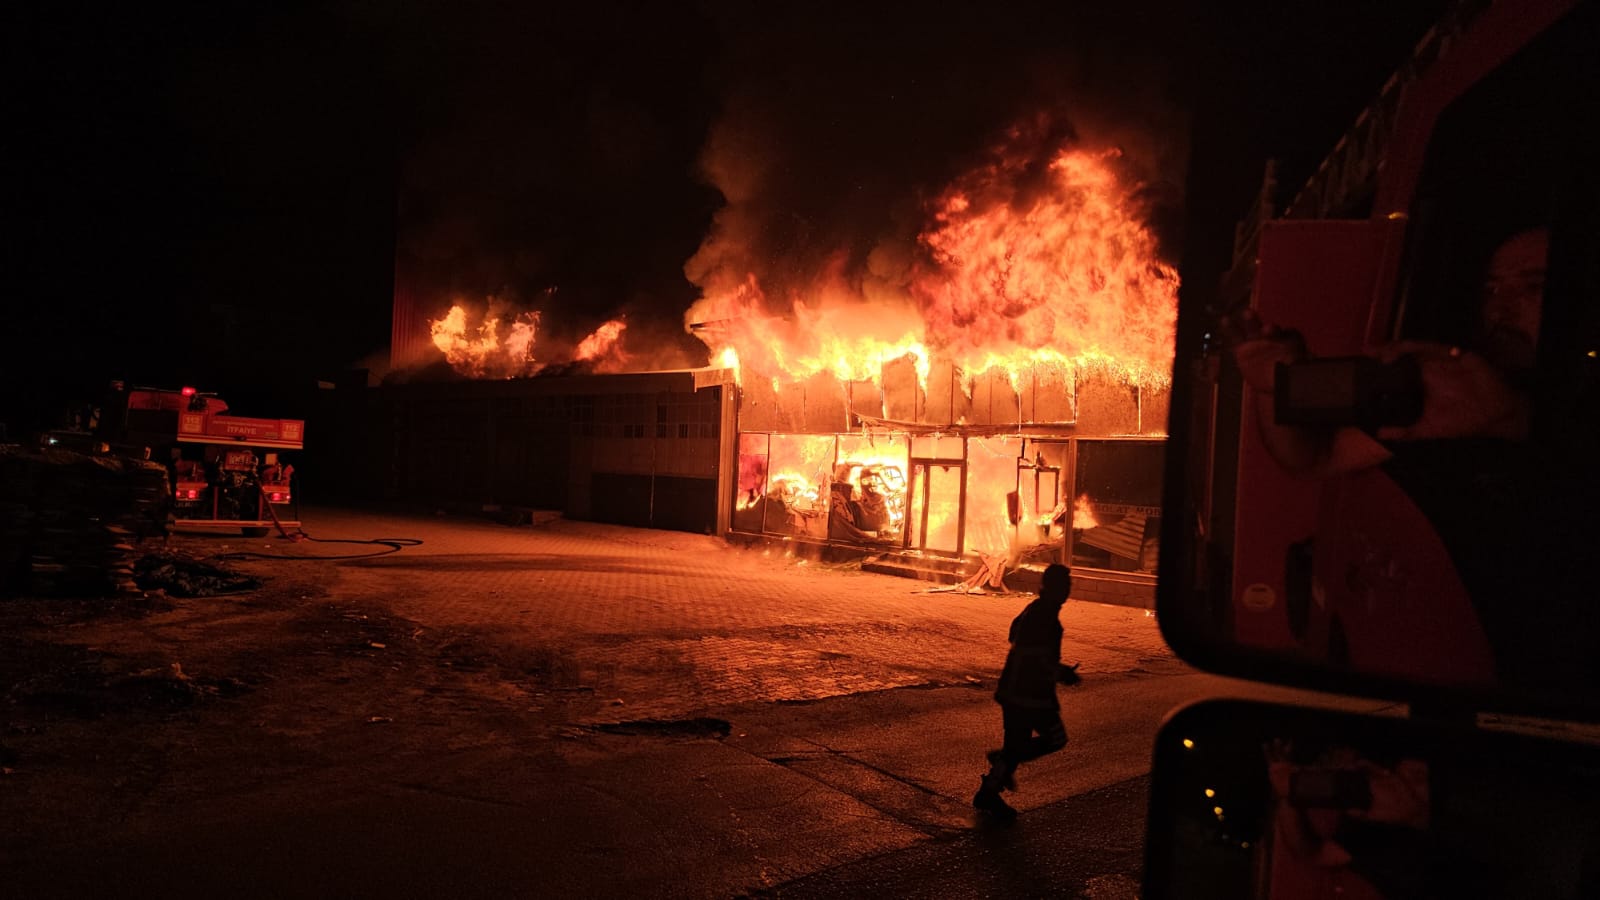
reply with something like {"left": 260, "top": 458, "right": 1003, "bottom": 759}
{"left": 219, "top": 509, "right": 1182, "bottom": 719}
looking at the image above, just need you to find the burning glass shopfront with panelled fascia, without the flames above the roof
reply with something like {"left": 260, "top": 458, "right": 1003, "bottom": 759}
{"left": 707, "top": 349, "right": 1166, "bottom": 605}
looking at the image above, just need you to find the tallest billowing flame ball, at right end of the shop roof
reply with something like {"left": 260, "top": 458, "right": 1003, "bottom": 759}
{"left": 912, "top": 149, "right": 1178, "bottom": 384}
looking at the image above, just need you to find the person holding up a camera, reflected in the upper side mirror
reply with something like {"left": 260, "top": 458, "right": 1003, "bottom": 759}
{"left": 1234, "top": 226, "right": 1600, "bottom": 692}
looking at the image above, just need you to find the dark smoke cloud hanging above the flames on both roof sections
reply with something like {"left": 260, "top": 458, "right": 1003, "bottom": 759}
{"left": 397, "top": 2, "right": 1186, "bottom": 364}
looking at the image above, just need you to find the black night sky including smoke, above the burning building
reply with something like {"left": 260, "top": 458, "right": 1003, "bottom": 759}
{"left": 0, "top": 0, "right": 1443, "bottom": 431}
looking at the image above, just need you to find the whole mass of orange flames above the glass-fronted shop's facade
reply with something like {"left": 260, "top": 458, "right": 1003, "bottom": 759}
{"left": 686, "top": 127, "right": 1178, "bottom": 395}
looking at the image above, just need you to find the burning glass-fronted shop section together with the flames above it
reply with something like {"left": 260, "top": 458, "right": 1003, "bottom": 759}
{"left": 686, "top": 123, "right": 1178, "bottom": 605}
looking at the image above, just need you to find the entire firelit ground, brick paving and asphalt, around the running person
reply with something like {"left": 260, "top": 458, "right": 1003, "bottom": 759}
{"left": 0, "top": 511, "right": 1379, "bottom": 898}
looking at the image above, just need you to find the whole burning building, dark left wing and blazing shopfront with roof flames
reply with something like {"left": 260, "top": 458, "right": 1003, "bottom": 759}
{"left": 371, "top": 110, "right": 1178, "bottom": 605}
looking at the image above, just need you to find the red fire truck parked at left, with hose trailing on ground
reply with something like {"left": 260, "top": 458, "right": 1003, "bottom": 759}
{"left": 93, "top": 383, "right": 306, "bottom": 536}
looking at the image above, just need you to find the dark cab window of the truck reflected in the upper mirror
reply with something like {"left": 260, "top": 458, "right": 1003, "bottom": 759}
{"left": 1392, "top": 5, "right": 1600, "bottom": 371}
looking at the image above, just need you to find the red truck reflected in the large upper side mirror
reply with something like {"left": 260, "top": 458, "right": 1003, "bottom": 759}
{"left": 1163, "top": 0, "right": 1600, "bottom": 690}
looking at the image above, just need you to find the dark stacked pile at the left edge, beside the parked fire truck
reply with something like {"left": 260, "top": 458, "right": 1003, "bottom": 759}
{"left": 0, "top": 445, "right": 171, "bottom": 597}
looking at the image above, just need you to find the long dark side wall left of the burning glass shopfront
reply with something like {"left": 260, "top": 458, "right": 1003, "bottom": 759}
{"left": 337, "top": 372, "right": 725, "bottom": 532}
